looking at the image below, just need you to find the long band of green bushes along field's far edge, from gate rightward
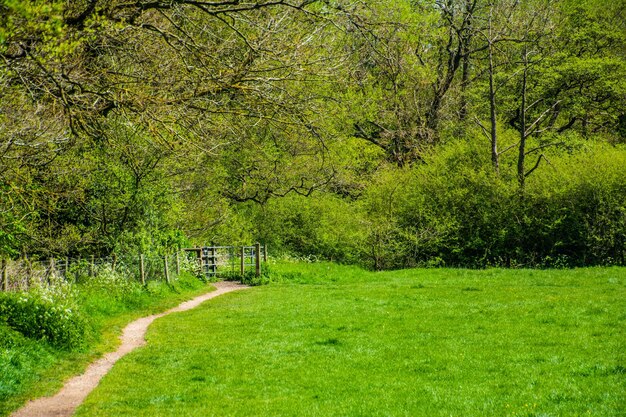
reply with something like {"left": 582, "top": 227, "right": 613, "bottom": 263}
{"left": 260, "top": 138, "right": 626, "bottom": 269}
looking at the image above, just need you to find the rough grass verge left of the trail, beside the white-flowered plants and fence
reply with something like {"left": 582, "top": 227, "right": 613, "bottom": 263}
{"left": 0, "top": 274, "right": 208, "bottom": 416}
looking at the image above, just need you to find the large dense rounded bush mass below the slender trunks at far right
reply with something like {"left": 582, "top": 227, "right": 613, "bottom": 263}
{"left": 395, "top": 143, "right": 626, "bottom": 267}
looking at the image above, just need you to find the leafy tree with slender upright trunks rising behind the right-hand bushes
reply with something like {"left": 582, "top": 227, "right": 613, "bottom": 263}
{"left": 476, "top": 1, "right": 623, "bottom": 188}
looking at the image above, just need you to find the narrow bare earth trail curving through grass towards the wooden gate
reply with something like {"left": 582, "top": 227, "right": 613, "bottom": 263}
{"left": 12, "top": 282, "right": 249, "bottom": 417}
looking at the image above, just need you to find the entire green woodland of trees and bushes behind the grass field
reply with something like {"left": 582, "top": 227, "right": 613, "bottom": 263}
{"left": 0, "top": 0, "right": 626, "bottom": 270}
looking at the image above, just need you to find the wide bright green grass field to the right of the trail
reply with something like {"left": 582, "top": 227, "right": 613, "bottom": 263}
{"left": 77, "top": 263, "right": 626, "bottom": 417}
